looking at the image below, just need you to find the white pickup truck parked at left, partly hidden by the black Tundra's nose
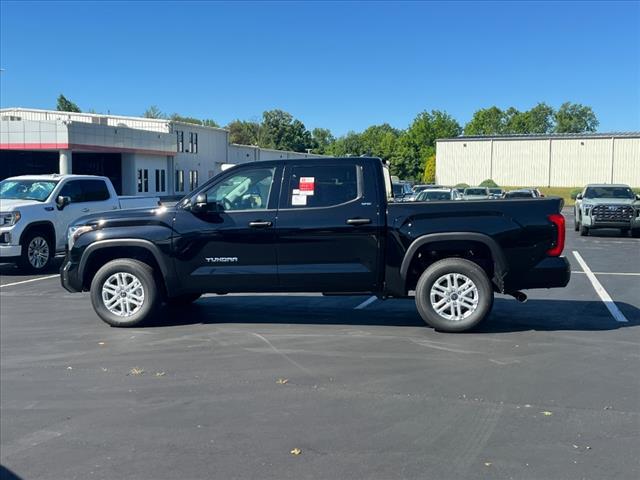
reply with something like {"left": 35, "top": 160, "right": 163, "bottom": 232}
{"left": 0, "top": 174, "right": 160, "bottom": 272}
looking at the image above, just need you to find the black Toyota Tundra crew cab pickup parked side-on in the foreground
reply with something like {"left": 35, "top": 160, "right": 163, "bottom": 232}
{"left": 61, "top": 158, "right": 570, "bottom": 332}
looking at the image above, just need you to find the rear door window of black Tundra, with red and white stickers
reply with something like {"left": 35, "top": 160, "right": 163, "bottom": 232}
{"left": 284, "top": 164, "right": 360, "bottom": 208}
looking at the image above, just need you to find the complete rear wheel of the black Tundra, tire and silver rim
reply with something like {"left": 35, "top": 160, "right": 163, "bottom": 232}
{"left": 416, "top": 258, "right": 493, "bottom": 332}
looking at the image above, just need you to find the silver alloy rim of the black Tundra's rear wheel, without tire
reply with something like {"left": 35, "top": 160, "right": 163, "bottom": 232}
{"left": 430, "top": 273, "right": 479, "bottom": 321}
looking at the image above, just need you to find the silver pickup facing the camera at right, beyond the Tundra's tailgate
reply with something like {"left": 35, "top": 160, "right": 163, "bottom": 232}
{"left": 573, "top": 184, "right": 640, "bottom": 237}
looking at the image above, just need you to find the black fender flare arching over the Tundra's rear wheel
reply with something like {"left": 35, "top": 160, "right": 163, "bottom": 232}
{"left": 400, "top": 232, "right": 509, "bottom": 292}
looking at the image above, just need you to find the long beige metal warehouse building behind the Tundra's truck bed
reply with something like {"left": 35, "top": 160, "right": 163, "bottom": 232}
{"left": 436, "top": 132, "right": 640, "bottom": 187}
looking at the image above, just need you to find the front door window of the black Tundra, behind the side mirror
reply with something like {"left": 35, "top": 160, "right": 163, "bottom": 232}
{"left": 206, "top": 168, "right": 275, "bottom": 210}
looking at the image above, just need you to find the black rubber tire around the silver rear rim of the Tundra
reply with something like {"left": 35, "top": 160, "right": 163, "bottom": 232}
{"left": 416, "top": 258, "right": 493, "bottom": 332}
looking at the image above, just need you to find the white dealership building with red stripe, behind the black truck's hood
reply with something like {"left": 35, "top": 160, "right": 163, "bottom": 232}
{"left": 0, "top": 108, "right": 319, "bottom": 196}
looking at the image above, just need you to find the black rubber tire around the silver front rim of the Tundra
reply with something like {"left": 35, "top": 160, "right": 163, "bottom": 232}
{"left": 91, "top": 258, "right": 161, "bottom": 327}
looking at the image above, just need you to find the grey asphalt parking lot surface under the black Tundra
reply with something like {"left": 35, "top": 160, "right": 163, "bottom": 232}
{"left": 0, "top": 210, "right": 640, "bottom": 480}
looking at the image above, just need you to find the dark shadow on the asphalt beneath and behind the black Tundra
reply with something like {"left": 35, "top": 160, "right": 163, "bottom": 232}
{"left": 147, "top": 295, "right": 640, "bottom": 333}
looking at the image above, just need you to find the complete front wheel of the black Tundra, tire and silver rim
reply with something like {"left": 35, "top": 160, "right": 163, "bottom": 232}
{"left": 91, "top": 259, "right": 160, "bottom": 327}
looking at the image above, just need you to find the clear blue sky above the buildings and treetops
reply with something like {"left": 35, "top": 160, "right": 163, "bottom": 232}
{"left": 0, "top": 0, "right": 640, "bottom": 135}
